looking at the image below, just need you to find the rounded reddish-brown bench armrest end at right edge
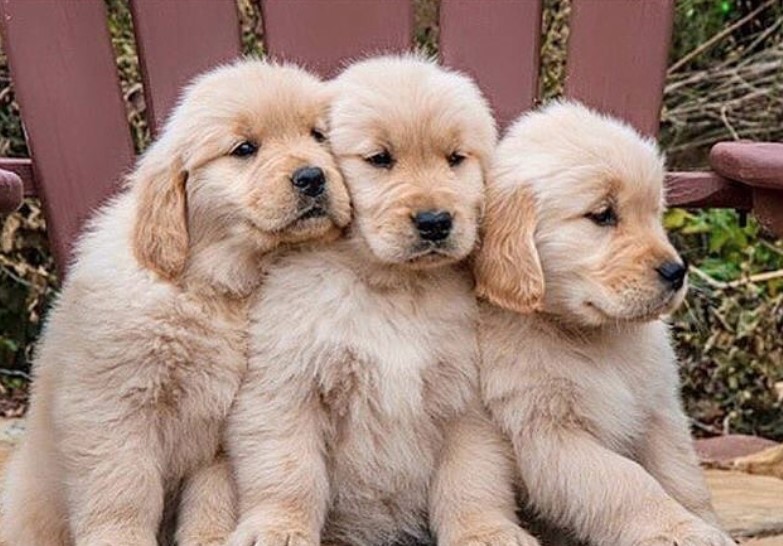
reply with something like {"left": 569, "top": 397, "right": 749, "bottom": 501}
{"left": 710, "top": 142, "right": 783, "bottom": 191}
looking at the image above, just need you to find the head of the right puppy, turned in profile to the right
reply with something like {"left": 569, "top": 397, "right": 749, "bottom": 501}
{"left": 476, "top": 103, "right": 686, "bottom": 326}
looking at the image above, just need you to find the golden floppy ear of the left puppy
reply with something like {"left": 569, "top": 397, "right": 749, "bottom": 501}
{"left": 131, "top": 139, "right": 188, "bottom": 281}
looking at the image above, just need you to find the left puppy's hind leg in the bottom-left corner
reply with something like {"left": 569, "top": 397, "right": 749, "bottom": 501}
{"left": 0, "top": 407, "right": 71, "bottom": 546}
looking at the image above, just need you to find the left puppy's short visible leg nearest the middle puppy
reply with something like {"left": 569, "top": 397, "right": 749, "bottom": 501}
{"left": 176, "top": 454, "right": 237, "bottom": 546}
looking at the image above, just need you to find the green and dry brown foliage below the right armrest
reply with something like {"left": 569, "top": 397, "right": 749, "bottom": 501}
{"left": 666, "top": 209, "right": 783, "bottom": 439}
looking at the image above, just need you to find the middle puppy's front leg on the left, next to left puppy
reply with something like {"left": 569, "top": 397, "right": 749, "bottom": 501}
{"left": 226, "top": 378, "right": 329, "bottom": 546}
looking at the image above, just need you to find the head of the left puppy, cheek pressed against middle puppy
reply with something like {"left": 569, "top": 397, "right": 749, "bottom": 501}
{"left": 130, "top": 61, "right": 350, "bottom": 279}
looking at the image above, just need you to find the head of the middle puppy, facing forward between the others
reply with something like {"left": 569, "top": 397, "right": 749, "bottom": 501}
{"left": 330, "top": 56, "right": 496, "bottom": 268}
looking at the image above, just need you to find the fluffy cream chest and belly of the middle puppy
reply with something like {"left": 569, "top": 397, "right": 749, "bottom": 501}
{"left": 316, "top": 288, "right": 476, "bottom": 480}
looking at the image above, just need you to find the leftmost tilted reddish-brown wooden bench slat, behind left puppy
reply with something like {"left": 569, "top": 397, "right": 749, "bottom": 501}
{"left": 0, "top": 0, "right": 133, "bottom": 273}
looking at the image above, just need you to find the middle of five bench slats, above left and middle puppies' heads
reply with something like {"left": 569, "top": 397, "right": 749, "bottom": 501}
{"left": 261, "top": 0, "right": 413, "bottom": 77}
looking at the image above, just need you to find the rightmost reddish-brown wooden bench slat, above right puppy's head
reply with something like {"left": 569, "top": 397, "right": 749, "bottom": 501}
{"left": 565, "top": 0, "right": 674, "bottom": 135}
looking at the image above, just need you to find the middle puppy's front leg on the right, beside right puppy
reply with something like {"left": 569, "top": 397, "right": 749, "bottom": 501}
{"left": 430, "top": 409, "right": 538, "bottom": 546}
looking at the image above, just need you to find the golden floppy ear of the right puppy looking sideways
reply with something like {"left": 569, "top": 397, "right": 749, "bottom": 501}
{"left": 473, "top": 184, "right": 544, "bottom": 313}
